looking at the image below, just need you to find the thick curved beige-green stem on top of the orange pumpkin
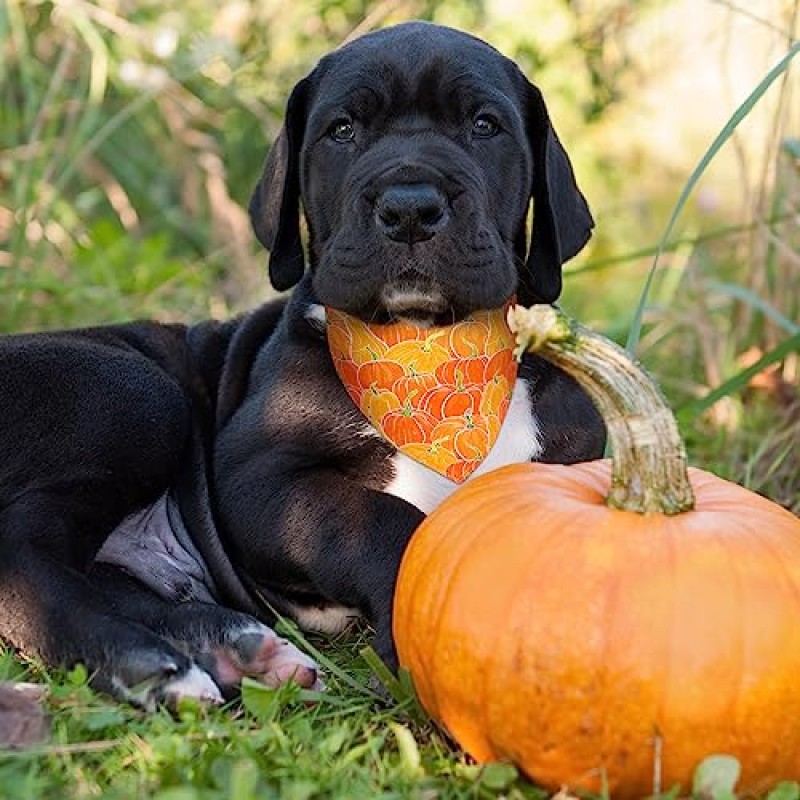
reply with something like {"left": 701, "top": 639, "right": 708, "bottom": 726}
{"left": 508, "top": 305, "right": 694, "bottom": 514}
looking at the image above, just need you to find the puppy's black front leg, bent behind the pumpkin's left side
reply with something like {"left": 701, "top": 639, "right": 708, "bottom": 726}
{"left": 212, "top": 451, "right": 424, "bottom": 669}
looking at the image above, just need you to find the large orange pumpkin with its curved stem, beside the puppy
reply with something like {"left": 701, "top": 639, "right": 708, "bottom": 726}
{"left": 394, "top": 307, "right": 800, "bottom": 800}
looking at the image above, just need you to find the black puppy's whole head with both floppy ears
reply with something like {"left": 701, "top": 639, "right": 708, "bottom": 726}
{"left": 250, "top": 22, "right": 593, "bottom": 324}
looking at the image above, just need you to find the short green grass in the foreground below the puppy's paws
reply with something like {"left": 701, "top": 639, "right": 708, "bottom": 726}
{"left": 0, "top": 636, "right": 546, "bottom": 800}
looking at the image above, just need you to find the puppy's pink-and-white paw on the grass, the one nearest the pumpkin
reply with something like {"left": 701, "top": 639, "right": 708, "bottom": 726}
{"left": 197, "top": 620, "right": 324, "bottom": 695}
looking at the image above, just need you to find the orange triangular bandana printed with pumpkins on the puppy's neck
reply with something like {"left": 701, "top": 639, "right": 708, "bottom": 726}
{"left": 326, "top": 304, "right": 517, "bottom": 483}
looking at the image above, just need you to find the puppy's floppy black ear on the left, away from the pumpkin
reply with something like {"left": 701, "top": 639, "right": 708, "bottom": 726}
{"left": 250, "top": 78, "right": 309, "bottom": 291}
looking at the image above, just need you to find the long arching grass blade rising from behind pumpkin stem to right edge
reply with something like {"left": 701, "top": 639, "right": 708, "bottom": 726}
{"left": 625, "top": 42, "right": 800, "bottom": 354}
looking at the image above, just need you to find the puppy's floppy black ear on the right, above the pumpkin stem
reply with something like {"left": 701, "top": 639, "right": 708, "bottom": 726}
{"left": 518, "top": 83, "right": 594, "bottom": 305}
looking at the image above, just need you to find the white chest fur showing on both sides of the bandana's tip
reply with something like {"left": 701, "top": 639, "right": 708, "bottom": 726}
{"left": 383, "top": 380, "right": 542, "bottom": 514}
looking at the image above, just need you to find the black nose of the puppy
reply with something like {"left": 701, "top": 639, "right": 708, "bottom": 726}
{"left": 375, "top": 183, "right": 448, "bottom": 244}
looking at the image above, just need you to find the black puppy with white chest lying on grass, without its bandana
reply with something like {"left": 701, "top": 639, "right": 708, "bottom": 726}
{"left": 0, "top": 23, "right": 604, "bottom": 705}
